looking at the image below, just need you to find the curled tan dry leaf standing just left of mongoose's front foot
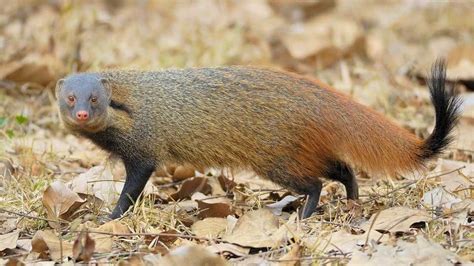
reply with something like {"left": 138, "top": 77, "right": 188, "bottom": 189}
{"left": 43, "top": 180, "right": 85, "bottom": 228}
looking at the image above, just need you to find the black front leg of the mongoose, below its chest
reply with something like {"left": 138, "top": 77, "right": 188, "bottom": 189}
{"left": 109, "top": 160, "right": 155, "bottom": 219}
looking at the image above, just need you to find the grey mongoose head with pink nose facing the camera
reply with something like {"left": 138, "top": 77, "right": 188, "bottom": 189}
{"left": 56, "top": 73, "right": 111, "bottom": 132}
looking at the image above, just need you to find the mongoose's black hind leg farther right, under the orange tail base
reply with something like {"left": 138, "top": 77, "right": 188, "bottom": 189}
{"left": 326, "top": 161, "right": 359, "bottom": 200}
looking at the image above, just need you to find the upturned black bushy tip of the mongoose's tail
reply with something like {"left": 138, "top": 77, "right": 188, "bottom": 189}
{"left": 420, "top": 59, "right": 462, "bottom": 161}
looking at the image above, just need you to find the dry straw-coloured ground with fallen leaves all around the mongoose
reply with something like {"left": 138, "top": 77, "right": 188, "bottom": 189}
{"left": 0, "top": 0, "right": 474, "bottom": 265}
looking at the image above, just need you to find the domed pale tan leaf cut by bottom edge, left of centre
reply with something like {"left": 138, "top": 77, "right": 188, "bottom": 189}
{"left": 157, "top": 245, "right": 228, "bottom": 266}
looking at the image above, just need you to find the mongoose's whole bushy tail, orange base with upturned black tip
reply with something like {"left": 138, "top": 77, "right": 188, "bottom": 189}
{"left": 337, "top": 60, "right": 461, "bottom": 174}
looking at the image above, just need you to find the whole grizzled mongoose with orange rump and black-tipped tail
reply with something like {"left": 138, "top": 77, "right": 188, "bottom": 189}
{"left": 56, "top": 60, "right": 460, "bottom": 219}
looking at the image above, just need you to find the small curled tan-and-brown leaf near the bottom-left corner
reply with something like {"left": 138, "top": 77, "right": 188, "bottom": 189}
{"left": 31, "top": 230, "right": 72, "bottom": 261}
